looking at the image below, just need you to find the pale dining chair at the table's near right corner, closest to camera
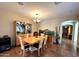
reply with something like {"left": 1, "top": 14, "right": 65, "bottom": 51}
{"left": 30, "top": 38, "right": 43, "bottom": 56}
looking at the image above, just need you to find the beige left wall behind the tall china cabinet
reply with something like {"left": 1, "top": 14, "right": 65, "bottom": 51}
{"left": 0, "top": 10, "right": 36, "bottom": 45}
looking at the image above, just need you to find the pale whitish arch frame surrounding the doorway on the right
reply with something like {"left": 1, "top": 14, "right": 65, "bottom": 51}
{"left": 59, "top": 20, "right": 79, "bottom": 49}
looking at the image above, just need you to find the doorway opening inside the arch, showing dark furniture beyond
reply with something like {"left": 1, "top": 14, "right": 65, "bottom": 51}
{"left": 62, "top": 25, "right": 73, "bottom": 50}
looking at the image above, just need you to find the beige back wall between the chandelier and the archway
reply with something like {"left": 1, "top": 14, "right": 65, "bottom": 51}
{"left": 40, "top": 18, "right": 63, "bottom": 31}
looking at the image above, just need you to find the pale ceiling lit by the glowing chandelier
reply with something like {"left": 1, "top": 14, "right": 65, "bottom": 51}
{"left": 0, "top": 2, "right": 79, "bottom": 20}
